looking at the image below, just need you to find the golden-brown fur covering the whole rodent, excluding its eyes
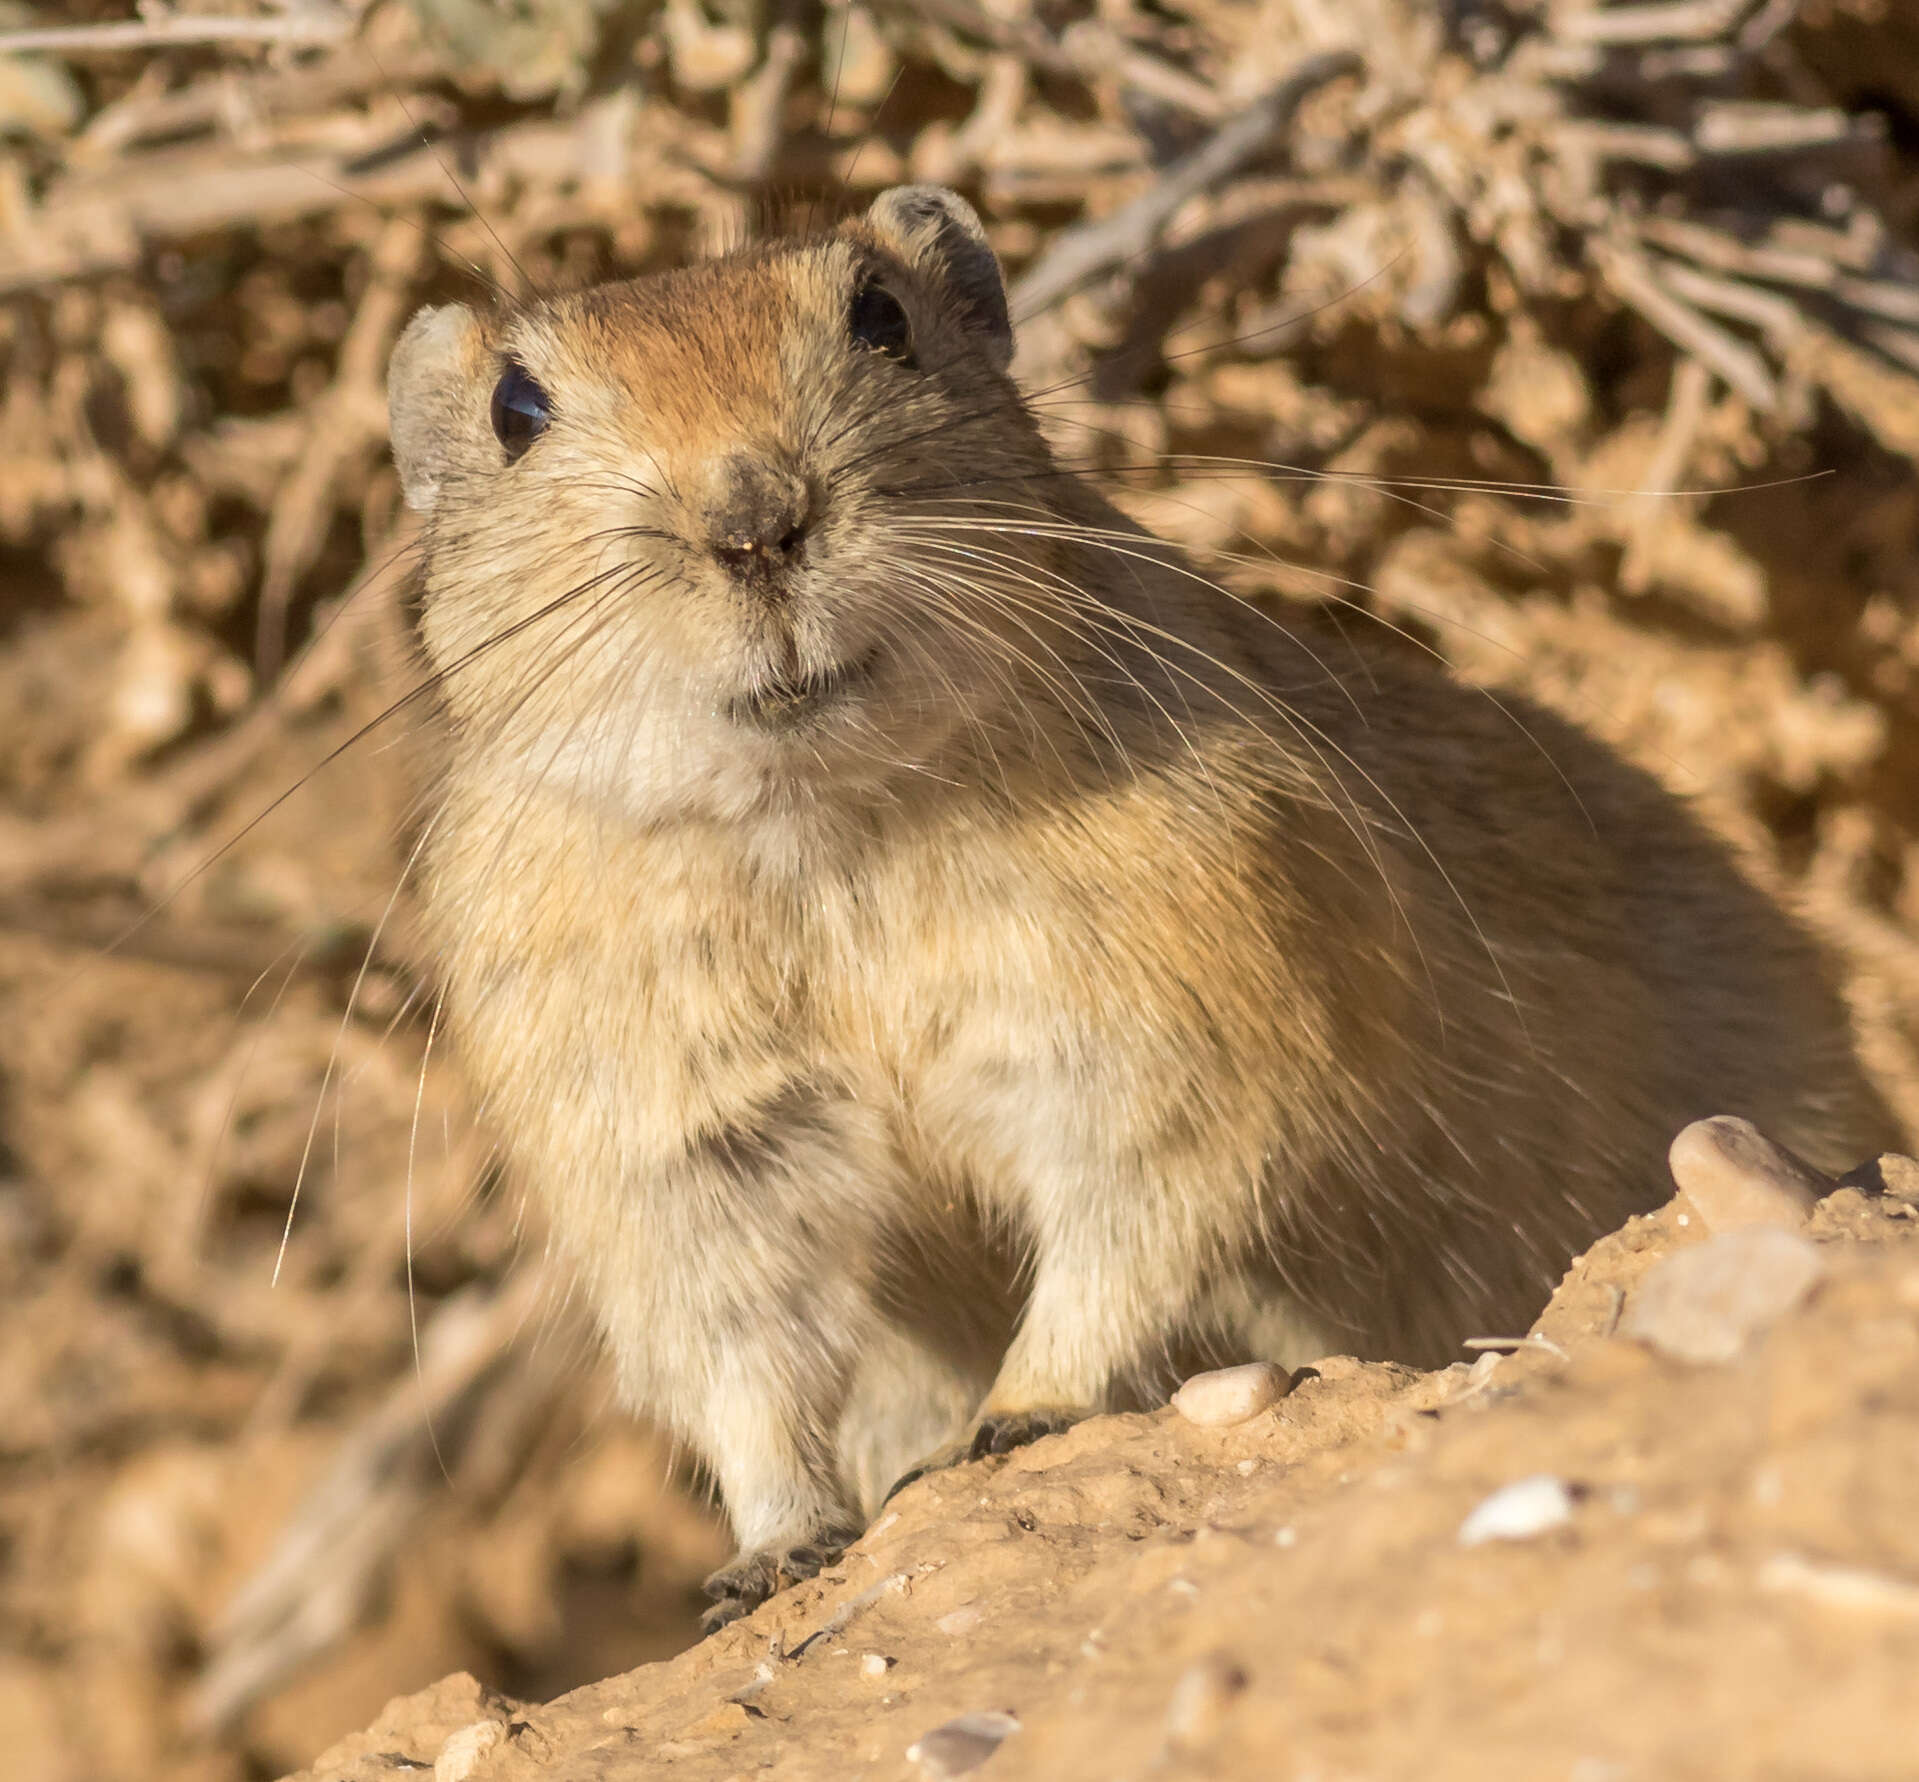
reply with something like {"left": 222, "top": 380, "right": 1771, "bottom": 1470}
{"left": 381, "top": 190, "right": 1890, "bottom": 1617}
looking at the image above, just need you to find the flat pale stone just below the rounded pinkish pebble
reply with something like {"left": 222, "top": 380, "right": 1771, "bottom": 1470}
{"left": 1620, "top": 1226, "right": 1823, "bottom": 1364}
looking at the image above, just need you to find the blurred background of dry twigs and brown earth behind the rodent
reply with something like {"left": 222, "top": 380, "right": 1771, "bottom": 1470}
{"left": 0, "top": 0, "right": 1919, "bottom": 1782}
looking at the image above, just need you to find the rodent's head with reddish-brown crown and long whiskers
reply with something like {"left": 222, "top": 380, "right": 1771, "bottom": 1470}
{"left": 390, "top": 186, "right": 1057, "bottom": 815}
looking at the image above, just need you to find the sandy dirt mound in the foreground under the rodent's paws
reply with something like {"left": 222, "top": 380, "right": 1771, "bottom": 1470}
{"left": 284, "top": 1166, "right": 1919, "bottom": 1782}
